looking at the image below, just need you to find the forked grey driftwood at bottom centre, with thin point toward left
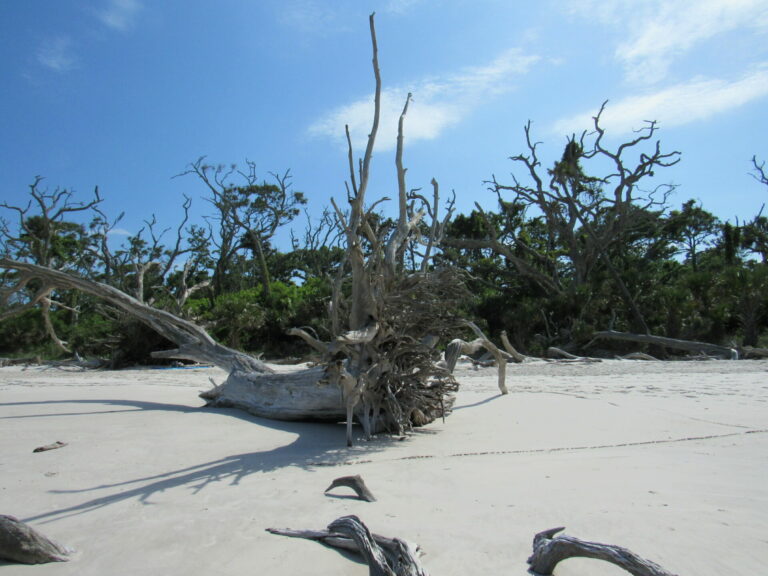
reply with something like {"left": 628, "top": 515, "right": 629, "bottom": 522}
{"left": 267, "top": 516, "right": 429, "bottom": 576}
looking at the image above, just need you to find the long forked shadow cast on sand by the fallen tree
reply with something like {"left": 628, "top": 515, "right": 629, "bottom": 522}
{"left": 0, "top": 399, "right": 398, "bottom": 524}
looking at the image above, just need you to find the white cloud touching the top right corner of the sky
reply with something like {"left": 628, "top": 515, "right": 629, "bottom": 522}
{"left": 571, "top": 0, "right": 768, "bottom": 84}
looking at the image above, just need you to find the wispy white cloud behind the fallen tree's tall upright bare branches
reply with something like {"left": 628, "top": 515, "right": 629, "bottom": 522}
{"left": 309, "top": 49, "right": 539, "bottom": 150}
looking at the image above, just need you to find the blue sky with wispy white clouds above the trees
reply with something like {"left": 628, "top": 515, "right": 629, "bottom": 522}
{"left": 0, "top": 0, "right": 768, "bottom": 250}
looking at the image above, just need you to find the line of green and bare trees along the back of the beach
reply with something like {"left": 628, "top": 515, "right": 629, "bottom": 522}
{"left": 0, "top": 106, "right": 768, "bottom": 365}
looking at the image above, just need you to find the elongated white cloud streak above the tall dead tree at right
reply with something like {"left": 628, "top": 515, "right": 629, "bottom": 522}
{"left": 551, "top": 66, "right": 768, "bottom": 136}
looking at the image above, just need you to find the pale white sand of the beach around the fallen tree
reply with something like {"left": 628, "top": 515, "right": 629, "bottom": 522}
{"left": 0, "top": 361, "right": 768, "bottom": 576}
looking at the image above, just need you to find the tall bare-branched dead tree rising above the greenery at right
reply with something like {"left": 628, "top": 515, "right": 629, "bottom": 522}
{"left": 446, "top": 103, "right": 680, "bottom": 332}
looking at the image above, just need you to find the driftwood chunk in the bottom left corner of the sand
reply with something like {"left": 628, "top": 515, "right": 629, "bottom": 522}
{"left": 0, "top": 514, "right": 69, "bottom": 564}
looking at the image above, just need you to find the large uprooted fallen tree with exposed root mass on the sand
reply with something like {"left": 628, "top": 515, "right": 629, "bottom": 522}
{"left": 0, "top": 14, "right": 472, "bottom": 444}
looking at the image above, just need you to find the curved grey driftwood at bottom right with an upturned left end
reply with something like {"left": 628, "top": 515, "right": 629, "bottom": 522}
{"left": 528, "top": 527, "right": 676, "bottom": 576}
